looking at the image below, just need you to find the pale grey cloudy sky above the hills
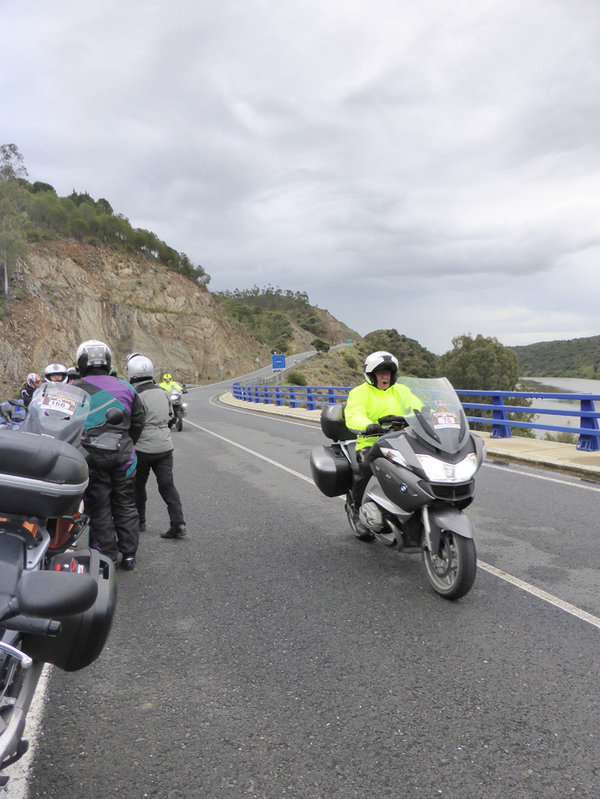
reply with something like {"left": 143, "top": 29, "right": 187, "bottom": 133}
{"left": 0, "top": 0, "right": 600, "bottom": 353}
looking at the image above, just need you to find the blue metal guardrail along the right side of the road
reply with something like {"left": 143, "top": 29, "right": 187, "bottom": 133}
{"left": 232, "top": 382, "right": 600, "bottom": 452}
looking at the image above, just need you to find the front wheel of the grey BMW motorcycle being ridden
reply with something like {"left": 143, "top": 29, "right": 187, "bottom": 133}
{"left": 422, "top": 530, "right": 477, "bottom": 599}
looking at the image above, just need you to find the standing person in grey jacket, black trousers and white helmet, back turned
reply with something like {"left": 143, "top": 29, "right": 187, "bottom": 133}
{"left": 126, "top": 353, "right": 186, "bottom": 538}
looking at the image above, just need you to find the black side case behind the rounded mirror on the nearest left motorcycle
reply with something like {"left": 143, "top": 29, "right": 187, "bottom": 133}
{"left": 23, "top": 549, "right": 117, "bottom": 671}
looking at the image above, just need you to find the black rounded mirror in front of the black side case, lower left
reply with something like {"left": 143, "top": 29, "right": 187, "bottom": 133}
{"left": 16, "top": 571, "right": 98, "bottom": 619}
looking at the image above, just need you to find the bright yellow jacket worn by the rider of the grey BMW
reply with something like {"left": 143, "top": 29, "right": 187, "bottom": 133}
{"left": 345, "top": 382, "right": 423, "bottom": 450}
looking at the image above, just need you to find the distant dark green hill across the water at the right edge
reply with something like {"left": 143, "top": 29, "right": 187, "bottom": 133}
{"left": 508, "top": 336, "right": 600, "bottom": 380}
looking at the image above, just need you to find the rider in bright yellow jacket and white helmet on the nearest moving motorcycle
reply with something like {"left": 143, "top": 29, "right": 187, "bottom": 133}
{"left": 345, "top": 350, "right": 423, "bottom": 533}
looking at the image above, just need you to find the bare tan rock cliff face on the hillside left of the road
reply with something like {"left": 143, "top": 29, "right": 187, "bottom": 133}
{"left": 0, "top": 240, "right": 351, "bottom": 399}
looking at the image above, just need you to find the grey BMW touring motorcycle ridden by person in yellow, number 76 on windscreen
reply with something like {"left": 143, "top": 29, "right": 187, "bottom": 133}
{"left": 310, "top": 378, "right": 485, "bottom": 599}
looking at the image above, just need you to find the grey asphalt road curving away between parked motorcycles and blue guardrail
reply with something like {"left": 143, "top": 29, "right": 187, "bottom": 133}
{"left": 9, "top": 387, "right": 600, "bottom": 799}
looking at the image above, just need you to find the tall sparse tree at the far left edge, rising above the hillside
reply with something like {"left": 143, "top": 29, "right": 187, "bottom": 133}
{"left": 0, "top": 144, "right": 27, "bottom": 297}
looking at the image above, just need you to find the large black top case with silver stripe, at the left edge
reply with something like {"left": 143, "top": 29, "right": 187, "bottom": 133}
{"left": 0, "top": 430, "right": 88, "bottom": 519}
